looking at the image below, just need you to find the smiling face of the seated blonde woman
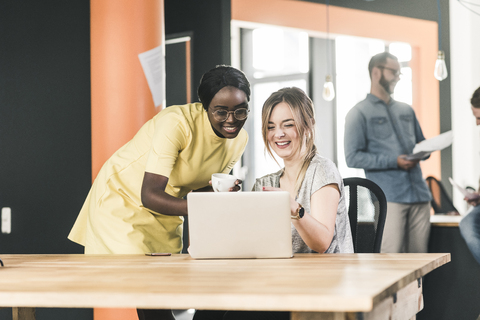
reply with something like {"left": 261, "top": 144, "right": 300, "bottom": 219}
{"left": 267, "top": 102, "right": 300, "bottom": 160}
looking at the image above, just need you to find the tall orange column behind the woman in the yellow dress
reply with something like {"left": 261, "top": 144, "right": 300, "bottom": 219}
{"left": 90, "top": 0, "right": 165, "bottom": 320}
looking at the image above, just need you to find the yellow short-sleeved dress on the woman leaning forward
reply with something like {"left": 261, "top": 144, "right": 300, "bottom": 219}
{"left": 68, "top": 103, "right": 248, "bottom": 254}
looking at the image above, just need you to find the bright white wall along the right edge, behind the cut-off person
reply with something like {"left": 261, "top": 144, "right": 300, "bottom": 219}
{"left": 450, "top": 0, "right": 480, "bottom": 213}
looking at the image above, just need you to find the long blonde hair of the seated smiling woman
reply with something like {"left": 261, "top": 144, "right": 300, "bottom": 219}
{"left": 262, "top": 87, "right": 317, "bottom": 194}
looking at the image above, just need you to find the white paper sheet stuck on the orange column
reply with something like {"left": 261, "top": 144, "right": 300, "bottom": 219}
{"left": 138, "top": 45, "right": 165, "bottom": 107}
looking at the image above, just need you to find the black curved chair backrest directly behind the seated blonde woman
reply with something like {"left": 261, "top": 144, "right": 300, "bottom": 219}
{"left": 343, "top": 178, "right": 387, "bottom": 253}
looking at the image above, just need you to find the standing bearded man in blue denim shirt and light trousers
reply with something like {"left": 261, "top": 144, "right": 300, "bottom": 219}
{"left": 345, "top": 52, "right": 431, "bottom": 253}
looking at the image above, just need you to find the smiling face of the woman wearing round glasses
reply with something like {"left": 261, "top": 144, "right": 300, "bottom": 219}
{"left": 207, "top": 87, "right": 248, "bottom": 139}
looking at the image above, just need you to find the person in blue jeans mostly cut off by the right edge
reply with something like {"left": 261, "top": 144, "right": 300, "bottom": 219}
{"left": 459, "top": 87, "right": 480, "bottom": 263}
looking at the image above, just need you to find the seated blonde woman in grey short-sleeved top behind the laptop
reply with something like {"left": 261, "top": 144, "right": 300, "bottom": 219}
{"left": 194, "top": 87, "right": 353, "bottom": 320}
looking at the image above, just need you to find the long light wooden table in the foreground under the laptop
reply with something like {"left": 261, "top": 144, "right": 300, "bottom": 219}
{"left": 0, "top": 253, "right": 450, "bottom": 320}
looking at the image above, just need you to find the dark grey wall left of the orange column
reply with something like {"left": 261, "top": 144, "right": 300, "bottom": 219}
{"left": 0, "top": 0, "right": 91, "bottom": 254}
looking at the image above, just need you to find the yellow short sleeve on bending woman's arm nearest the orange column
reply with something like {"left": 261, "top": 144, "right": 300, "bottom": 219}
{"left": 145, "top": 112, "right": 190, "bottom": 178}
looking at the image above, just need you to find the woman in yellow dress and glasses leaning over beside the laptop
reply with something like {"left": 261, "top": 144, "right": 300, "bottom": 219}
{"left": 68, "top": 66, "right": 250, "bottom": 320}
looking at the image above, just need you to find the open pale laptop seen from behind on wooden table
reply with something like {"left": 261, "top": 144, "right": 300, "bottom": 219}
{"left": 187, "top": 191, "right": 293, "bottom": 259}
